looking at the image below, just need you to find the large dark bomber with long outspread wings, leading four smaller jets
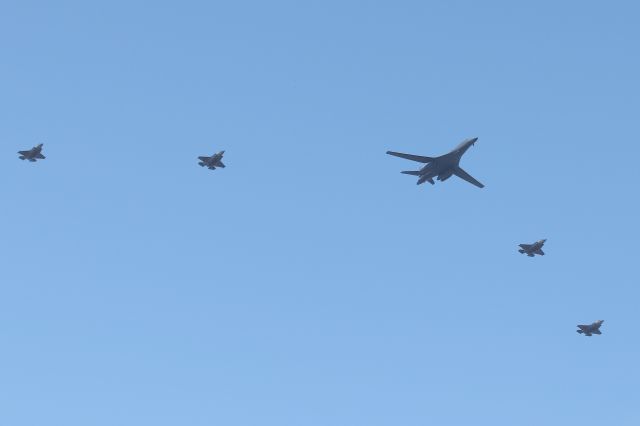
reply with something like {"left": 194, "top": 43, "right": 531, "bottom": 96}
{"left": 387, "top": 138, "right": 484, "bottom": 188}
